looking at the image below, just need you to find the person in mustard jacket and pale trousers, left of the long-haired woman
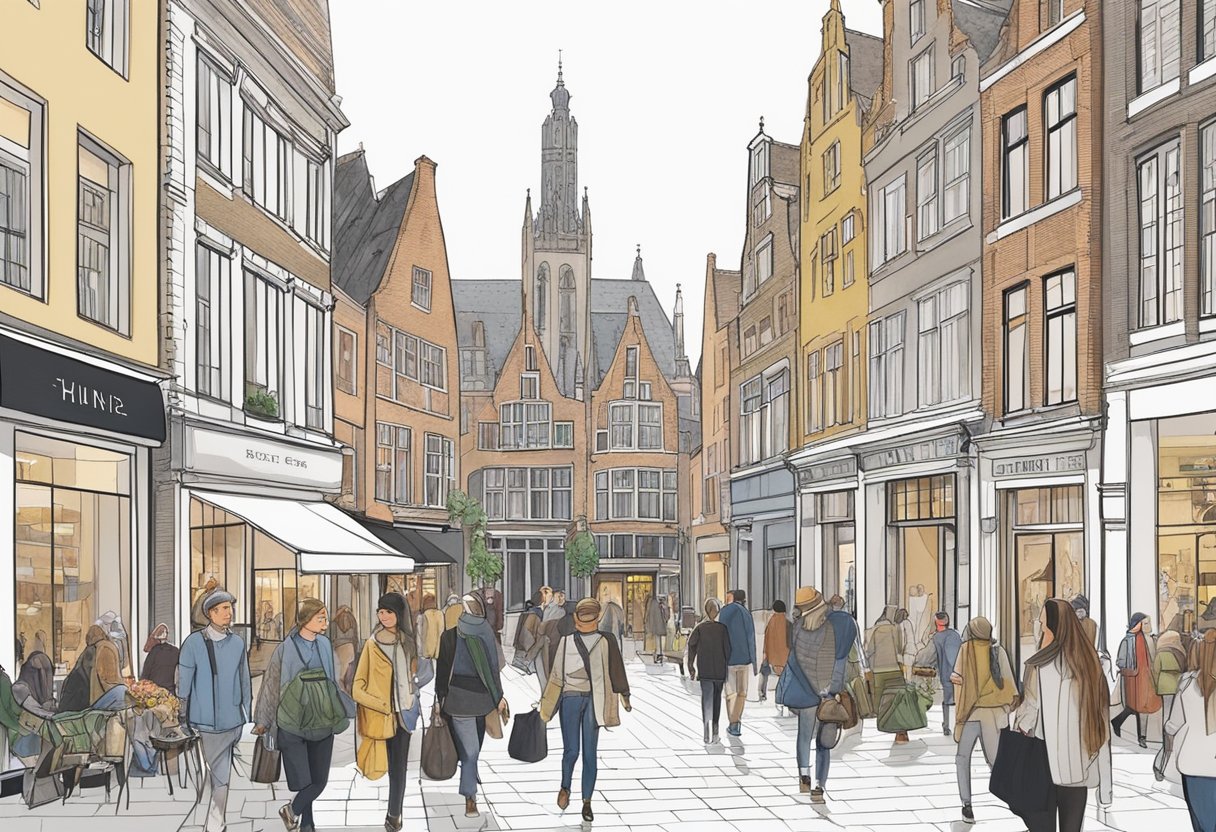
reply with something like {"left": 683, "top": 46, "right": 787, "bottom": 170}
{"left": 950, "top": 615, "right": 1018, "bottom": 823}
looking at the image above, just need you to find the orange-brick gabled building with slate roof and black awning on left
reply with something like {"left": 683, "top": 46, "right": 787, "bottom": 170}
{"left": 333, "top": 150, "right": 463, "bottom": 620}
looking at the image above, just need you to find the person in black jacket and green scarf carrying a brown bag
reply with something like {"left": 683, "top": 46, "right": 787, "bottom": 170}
{"left": 435, "top": 590, "right": 510, "bottom": 817}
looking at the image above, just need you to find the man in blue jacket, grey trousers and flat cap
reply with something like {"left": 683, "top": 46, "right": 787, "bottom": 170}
{"left": 178, "top": 586, "right": 253, "bottom": 832}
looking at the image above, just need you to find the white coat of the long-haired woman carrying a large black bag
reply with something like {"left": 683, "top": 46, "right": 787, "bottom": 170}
{"left": 1012, "top": 657, "right": 1111, "bottom": 805}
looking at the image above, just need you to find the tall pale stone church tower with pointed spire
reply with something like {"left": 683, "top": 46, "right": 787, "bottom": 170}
{"left": 522, "top": 58, "right": 591, "bottom": 398}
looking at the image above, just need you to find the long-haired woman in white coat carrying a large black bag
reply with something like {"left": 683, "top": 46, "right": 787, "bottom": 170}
{"left": 1013, "top": 598, "right": 1111, "bottom": 832}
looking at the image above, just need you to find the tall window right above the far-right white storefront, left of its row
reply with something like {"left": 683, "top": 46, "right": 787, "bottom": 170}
{"left": 1137, "top": 141, "right": 1183, "bottom": 327}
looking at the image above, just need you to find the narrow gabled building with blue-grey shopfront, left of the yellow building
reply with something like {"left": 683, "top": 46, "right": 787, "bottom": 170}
{"left": 728, "top": 120, "right": 800, "bottom": 609}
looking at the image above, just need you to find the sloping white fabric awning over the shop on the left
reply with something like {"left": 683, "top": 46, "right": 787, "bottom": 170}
{"left": 196, "top": 491, "right": 413, "bottom": 574}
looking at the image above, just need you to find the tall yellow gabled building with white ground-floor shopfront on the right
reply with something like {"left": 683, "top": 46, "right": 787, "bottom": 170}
{"left": 790, "top": 0, "right": 883, "bottom": 613}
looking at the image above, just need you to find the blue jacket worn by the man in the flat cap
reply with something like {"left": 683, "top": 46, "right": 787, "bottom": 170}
{"left": 178, "top": 630, "right": 253, "bottom": 732}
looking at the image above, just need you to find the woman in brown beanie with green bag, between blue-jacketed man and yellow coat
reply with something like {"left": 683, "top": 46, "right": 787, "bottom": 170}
{"left": 253, "top": 598, "right": 348, "bottom": 832}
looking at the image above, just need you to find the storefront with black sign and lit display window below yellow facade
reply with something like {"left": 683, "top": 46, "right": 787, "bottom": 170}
{"left": 0, "top": 331, "right": 165, "bottom": 679}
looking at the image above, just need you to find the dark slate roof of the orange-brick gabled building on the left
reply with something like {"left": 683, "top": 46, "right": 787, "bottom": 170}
{"left": 332, "top": 151, "right": 413, "bottom": 304}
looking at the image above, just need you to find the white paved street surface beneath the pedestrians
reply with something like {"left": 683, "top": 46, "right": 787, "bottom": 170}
{"left": 0, "top": 642, "right": 1189, "bottom": 832}
